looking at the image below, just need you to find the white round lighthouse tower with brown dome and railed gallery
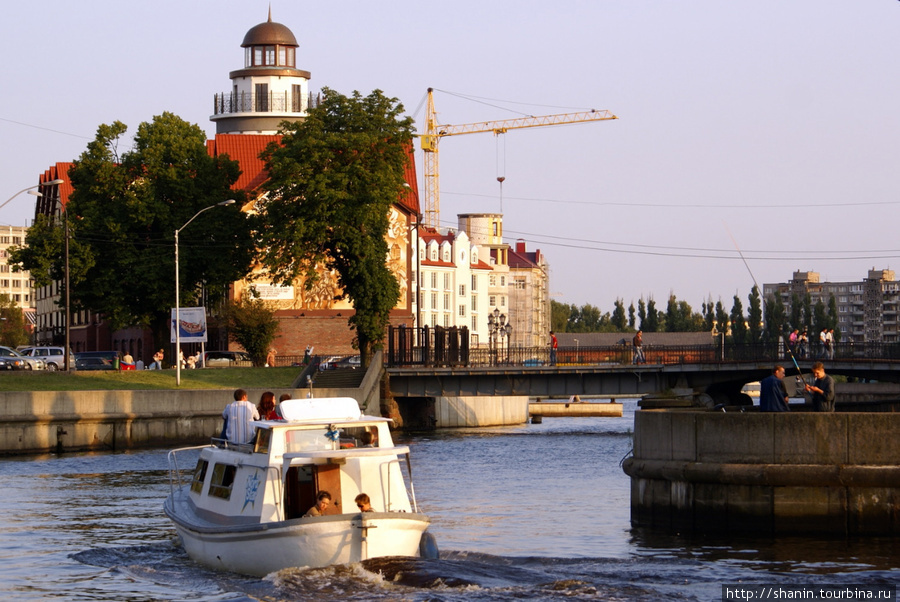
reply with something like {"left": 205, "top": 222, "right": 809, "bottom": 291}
{"left": 210, "top": 7, "right": 310, "bottom": 134}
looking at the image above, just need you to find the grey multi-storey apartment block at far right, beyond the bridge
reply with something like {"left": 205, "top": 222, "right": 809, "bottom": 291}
{"left": 763, "top": 268, "right": 900, "bottom": 343}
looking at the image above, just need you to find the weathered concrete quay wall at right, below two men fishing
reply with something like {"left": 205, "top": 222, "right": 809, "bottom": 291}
{"left": 624, "top": 410, "right": 900, "bottom": 535}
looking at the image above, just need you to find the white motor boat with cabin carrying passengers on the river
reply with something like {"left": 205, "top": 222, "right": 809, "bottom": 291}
{"left": 164, "top": 398, "right": 437, "bottom": 576}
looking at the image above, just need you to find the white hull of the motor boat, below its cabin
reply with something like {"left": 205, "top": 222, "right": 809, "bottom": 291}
{"left": 165, "top": 489, "right": 429, "bottom": 576}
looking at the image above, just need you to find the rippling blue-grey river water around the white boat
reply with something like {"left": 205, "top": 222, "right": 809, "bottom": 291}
{"left": 0, "top": 401, "right": 900, "bottom": 602}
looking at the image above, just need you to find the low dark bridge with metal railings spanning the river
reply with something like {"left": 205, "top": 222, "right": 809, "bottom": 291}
{"left": 385, "top": 329, "right": 900, "bottom": 405}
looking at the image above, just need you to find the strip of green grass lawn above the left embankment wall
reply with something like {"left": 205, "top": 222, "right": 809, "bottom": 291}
{"left": 0, "top": 367, "right": 303, "bottom": 391}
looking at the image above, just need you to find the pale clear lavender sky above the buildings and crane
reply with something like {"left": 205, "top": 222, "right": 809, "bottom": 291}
{"left": 0, "top": 0, "right": 900, "bottom": 311}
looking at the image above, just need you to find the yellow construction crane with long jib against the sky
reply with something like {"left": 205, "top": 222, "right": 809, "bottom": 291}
{"left": 421, "top": 88, "right": 618, "bottom": 228}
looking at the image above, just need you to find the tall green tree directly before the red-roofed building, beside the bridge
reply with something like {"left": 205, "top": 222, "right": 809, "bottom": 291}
{"left": 260, "top": 88, "right": 413, "bottom": 363}
